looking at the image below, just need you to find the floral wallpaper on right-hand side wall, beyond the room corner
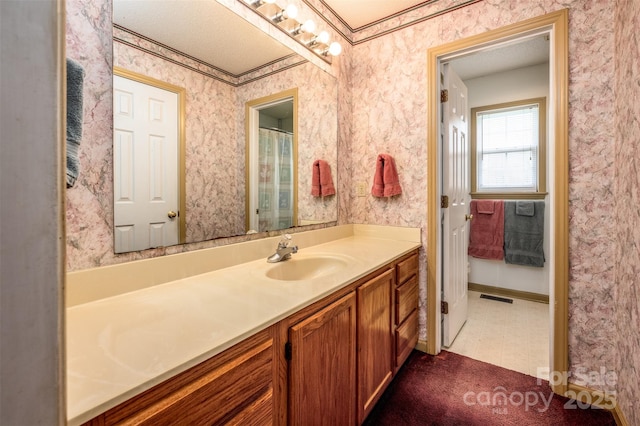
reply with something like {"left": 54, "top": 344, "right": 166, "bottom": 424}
{"left": 613, "top": 0, "right": 640, "bottom": 425}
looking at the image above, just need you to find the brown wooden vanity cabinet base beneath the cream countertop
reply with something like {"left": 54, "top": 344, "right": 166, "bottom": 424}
{"left": 80, "top": 251, "right": 418, "bottom": 426}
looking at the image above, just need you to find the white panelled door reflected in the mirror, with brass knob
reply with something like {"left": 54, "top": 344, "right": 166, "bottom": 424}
{"left": 113, "top": 75, "right": 179, "bottom": 253}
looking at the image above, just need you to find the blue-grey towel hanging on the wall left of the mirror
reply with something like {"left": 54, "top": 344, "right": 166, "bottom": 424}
{"left": 67, "top": 58, "right": 84, "bottom": 188}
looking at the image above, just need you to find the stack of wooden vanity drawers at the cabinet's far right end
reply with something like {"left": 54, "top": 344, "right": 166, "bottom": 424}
{"left": 395, "top": 252, "right": 418, "bottom": 372}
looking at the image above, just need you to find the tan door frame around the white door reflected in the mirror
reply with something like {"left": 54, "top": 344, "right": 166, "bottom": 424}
{"left": 113, "top": 65, "right": 187, "bottom": 244}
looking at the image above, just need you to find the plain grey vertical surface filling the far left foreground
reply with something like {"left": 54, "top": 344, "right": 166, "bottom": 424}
{"left": 0, "top": 0, "right": 65, "bottom": 425}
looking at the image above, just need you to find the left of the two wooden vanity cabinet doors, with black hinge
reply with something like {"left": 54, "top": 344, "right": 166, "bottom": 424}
{"left": 289, "top": 292, "right": 356, "bottom": 426}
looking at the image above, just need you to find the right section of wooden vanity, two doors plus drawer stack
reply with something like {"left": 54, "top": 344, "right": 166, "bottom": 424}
{"left": 287, "top": 251, "right": 418, "bottom": 426}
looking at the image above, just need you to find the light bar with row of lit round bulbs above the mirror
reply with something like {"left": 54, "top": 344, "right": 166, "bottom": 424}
{"left": 244, "top": 0, "right": 342, "bottom": 63}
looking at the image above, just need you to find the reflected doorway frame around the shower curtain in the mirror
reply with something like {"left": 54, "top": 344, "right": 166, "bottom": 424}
{"left": 244, "top": 87, "right": 299, "bottom": 232}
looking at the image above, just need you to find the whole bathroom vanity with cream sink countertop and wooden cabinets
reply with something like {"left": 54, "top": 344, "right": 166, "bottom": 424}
{"left": 67, "top": 225, "right": 420, "bottom": 425}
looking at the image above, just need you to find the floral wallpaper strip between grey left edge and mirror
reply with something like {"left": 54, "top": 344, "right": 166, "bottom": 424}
{"left": 65, "top": 0, "right": 113, "bottom": 271}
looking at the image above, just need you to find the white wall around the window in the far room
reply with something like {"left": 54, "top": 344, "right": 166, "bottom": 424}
{"left": 464, "top": 64, "right": 551, "bottom": 295}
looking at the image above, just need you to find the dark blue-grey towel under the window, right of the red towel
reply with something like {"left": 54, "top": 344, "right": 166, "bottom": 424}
{"left": 504, "top": 201, "right": 545, "bottom": 267}
